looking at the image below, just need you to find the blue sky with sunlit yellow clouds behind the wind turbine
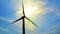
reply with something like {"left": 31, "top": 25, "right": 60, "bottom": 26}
{"left": 0, "top": 0, "right": 60, "bottom": 34}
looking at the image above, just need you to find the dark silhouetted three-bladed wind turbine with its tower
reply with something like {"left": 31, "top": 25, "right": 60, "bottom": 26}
{"left": 11, "top": 1, "right": 38, "bottom": 34}
